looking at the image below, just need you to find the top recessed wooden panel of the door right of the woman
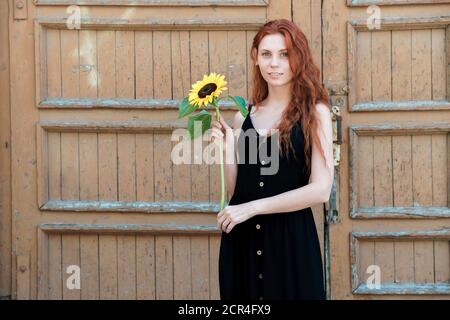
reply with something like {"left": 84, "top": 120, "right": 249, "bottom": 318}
{"left": 348, "top": 17, "right": 450, "bottom": 111}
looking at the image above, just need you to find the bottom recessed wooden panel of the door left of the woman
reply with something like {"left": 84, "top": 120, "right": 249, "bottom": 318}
{"left": 39, "top": 225, "right": 219, "bottom": 299}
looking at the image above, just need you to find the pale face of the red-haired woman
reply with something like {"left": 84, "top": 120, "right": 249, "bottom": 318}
{"left": 257, "top": 33, "right": 294, "bottom": 87}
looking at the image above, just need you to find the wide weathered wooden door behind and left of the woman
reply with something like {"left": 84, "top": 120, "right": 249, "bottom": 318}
{"left": 8, "top": 0, "right": 323, "bottom": 299}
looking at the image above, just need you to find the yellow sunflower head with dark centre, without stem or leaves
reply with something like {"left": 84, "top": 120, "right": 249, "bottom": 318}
{"left": 189, "top": 72, "right": 227, "bottom": 108}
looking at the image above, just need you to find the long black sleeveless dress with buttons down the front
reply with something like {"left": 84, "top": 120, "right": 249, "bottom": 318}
{"left": 219, "top": 105, "right": 325, "bottom": 300}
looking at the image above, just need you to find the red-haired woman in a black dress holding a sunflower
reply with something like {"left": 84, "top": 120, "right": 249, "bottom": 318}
{"left": 212, "top": 19, "right": 334, "bottom": 300}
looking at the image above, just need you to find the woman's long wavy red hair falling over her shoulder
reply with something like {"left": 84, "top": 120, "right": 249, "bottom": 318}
{"left": 250, "top": 19, "right": 330, "bottom": 177}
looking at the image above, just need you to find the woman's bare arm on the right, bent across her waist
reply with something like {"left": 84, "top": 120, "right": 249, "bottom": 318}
{"left": 248, "top": 103, "right": 334, "bottom": 216}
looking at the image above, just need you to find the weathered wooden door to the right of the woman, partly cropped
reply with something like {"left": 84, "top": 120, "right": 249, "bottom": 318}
{"left": 323, "top": 0, "right": 450, "bottom": 299}
